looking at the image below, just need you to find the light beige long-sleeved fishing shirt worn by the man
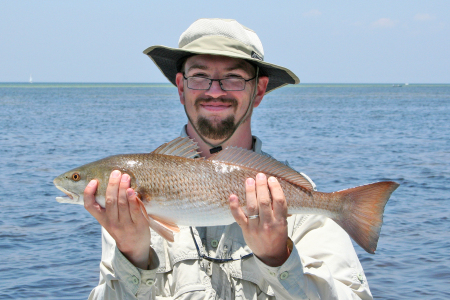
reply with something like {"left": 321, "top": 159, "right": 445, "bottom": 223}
{"left": 89, "top": 130, "right": 372, "bottom": 300}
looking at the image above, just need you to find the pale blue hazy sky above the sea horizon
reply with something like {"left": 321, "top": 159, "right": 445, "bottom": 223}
{"left": 0, "top": 0, "right": 450, "bottom": 83}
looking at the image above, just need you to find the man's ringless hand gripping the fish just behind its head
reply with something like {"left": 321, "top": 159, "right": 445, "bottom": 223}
{"left": 84, "top": 170, "right": 150, "bottom": 270}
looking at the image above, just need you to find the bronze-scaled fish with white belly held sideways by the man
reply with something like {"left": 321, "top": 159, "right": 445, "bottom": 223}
{"left": 53, "top": 137, "right": 399, "bottom": 254}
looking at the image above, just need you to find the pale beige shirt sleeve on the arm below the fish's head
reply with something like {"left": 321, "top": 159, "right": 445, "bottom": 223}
{"left": 89, "top": 228, "right": 159, "bottom": 300}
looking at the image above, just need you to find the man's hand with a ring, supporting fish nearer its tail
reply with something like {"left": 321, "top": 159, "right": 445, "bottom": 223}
{"left": 230, "top": 173, "right": 290, "bottom": 267}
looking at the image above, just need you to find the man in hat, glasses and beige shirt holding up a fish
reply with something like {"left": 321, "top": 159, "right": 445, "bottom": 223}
{"left": 84, "top": 19, "right": 372, "bottom": 299}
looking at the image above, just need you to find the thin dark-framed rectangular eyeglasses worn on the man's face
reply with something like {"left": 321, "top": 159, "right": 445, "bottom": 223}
{"left": 183, "top": 73, "right": 256, "bottom": 91}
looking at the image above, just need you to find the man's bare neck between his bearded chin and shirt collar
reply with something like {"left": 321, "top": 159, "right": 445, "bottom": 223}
{"left": 186, "top": 120, "right": 253, "bottom": 158}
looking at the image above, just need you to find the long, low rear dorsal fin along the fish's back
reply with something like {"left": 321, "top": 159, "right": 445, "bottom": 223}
{"left": 208, "top": 147, "right": 314, "bottom": 191}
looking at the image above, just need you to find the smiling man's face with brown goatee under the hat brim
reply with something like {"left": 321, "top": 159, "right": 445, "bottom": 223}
{"left": 177, "top": 55, "right": 259, "bottom": 140}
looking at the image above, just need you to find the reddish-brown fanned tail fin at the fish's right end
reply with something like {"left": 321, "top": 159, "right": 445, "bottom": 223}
{"left": 334, "top": 181, "right": 399, "bottom": 254}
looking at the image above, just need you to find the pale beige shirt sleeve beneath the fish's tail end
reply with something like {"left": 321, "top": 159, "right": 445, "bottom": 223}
{"left": 255, "top": 215, "right": 372, "bottom": 299}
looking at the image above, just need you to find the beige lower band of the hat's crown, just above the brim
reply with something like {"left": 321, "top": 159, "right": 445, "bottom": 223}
{"left": 180, "top": 35, "right": 262, "bottom": 60}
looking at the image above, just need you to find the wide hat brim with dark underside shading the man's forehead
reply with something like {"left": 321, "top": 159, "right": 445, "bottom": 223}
{"left": 144, "top": 45, "right": 300, "bottom": 94}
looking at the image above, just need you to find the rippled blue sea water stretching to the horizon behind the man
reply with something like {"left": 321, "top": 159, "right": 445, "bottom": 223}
{"left": 0, "top": 84, "right": 450, "bottom": 299}
